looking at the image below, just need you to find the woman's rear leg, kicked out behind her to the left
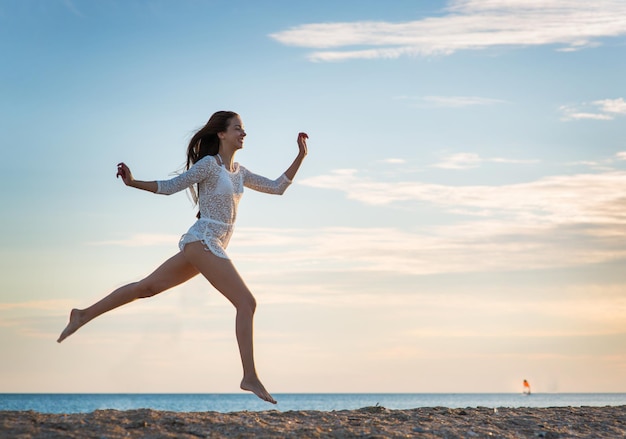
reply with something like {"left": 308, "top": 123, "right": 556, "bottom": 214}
{"left": 57, "top": 253, "right": 198, "bottom": 343}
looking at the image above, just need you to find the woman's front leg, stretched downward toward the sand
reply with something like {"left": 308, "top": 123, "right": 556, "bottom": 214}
{"left": 184, "top": 242, "right": 276, "bottom": 404}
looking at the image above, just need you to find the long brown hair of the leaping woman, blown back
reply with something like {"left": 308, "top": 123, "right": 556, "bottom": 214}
{"left": 186, "top": 111, "right": 238, "bottom": 218}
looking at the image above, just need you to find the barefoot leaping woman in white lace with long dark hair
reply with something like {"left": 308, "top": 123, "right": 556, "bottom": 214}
{"left": 57, "top": 111, "right": 308, "bottom": 404}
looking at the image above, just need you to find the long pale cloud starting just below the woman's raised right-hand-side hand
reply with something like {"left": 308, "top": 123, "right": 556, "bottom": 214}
{"left": 301, "top": 168, "right": 626, "bottom": 224}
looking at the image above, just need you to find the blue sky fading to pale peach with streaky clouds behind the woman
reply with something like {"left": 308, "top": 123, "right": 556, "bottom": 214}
{"left": 0, "top": 0, "right": 626, "bottom": 393}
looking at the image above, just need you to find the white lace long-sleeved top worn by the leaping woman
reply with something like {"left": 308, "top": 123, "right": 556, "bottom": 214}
{"left": 157, "top": 156, "right": 291, "bottom": 258}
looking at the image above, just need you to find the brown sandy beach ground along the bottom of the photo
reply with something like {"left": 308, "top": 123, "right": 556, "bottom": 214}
{"left": 0, "top": 406, "right": 626, "bottom": 439}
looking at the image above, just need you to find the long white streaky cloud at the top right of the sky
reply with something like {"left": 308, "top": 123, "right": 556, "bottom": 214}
{"left": 270, "top": 0, "right": 626, "bottom": 61}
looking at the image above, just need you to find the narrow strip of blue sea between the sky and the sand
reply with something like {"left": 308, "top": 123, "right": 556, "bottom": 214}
{"left": 0, "top": 393, "right": 626, "bottom": 413}
